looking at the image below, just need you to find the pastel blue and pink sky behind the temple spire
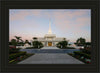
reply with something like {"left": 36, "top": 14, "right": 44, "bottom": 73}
{"left": 9, "top": 9, "right": 91, "bottom": 42}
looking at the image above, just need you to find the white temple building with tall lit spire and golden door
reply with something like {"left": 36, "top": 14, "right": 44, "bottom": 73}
{"left": 32, "top": 22, "right": 66, "bottom": 47}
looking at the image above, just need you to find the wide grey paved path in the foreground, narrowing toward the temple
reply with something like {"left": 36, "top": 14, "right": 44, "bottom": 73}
{"left": 18, "top": 53, "right": 84, "bottom": 64}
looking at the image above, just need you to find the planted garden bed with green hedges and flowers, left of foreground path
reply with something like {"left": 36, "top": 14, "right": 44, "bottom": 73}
{"left": 8, "top": 48, "right": 33, "bottom": 64}
